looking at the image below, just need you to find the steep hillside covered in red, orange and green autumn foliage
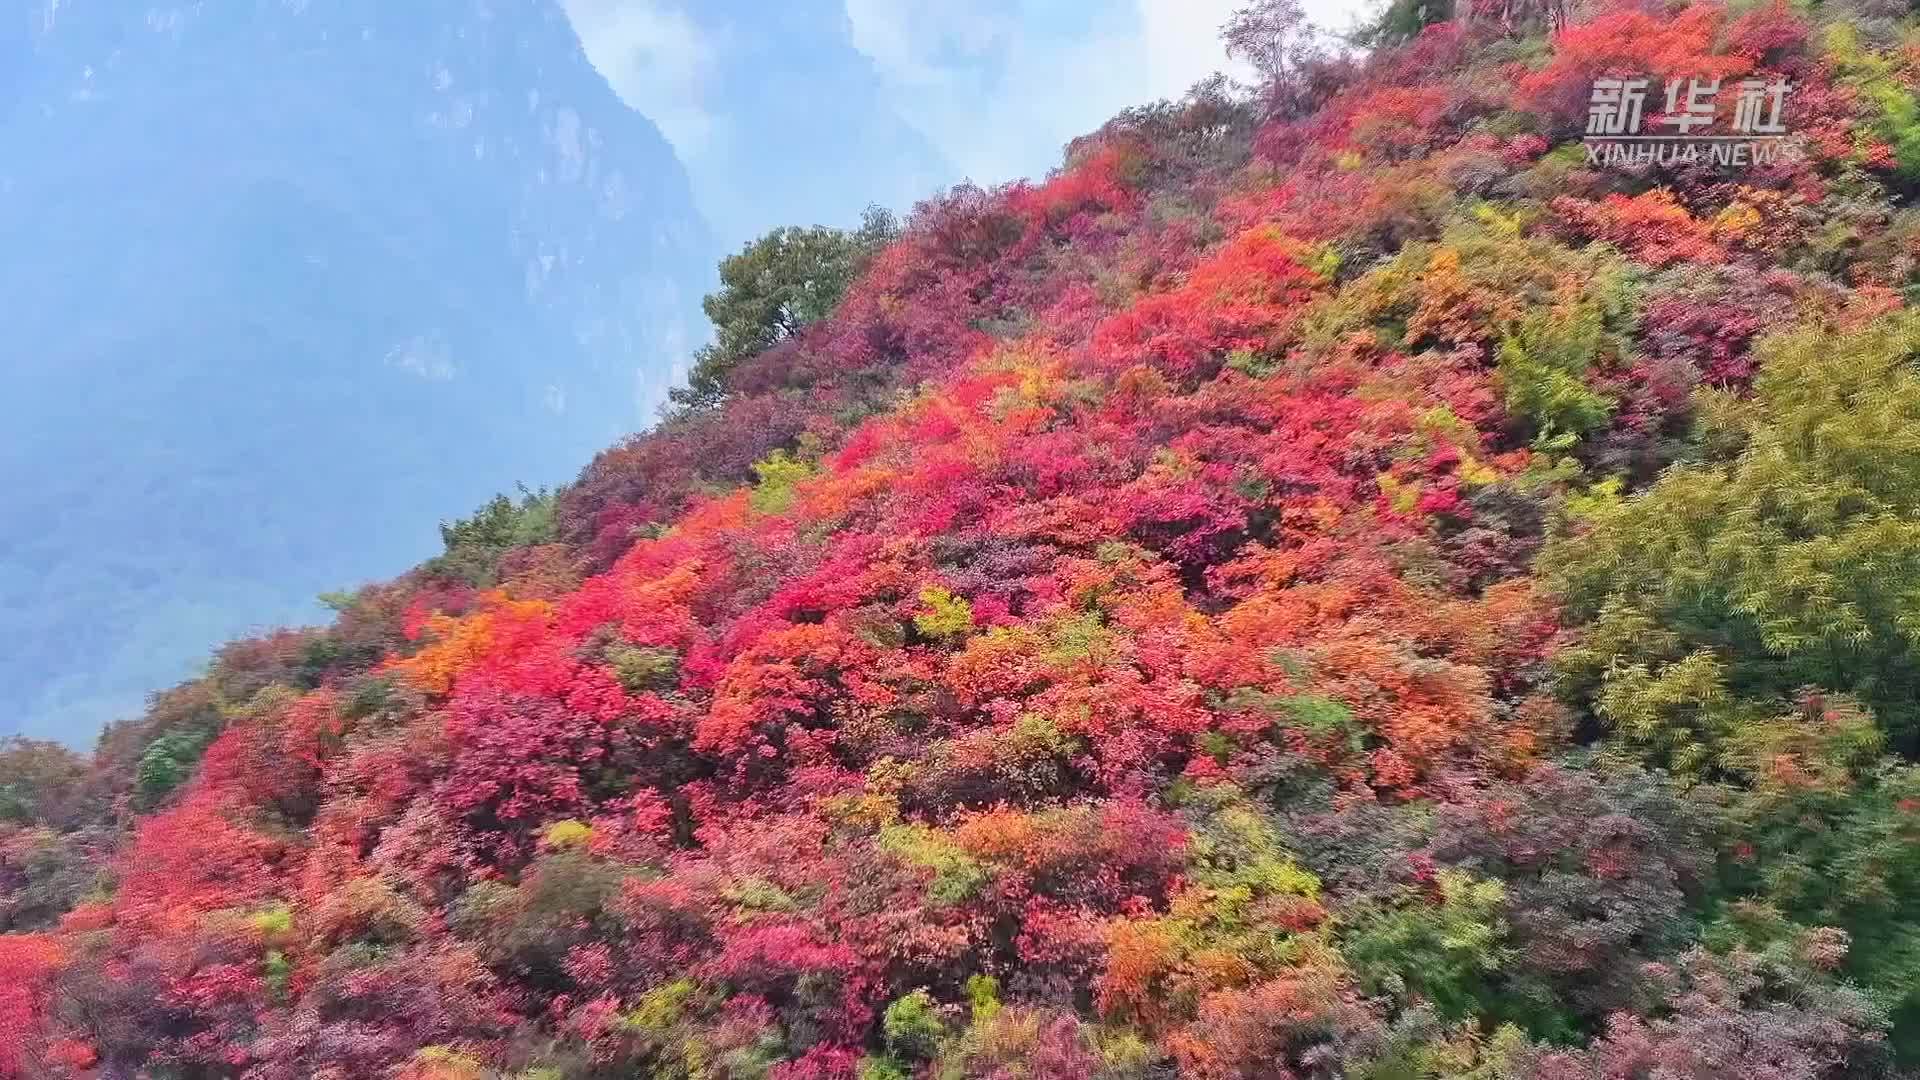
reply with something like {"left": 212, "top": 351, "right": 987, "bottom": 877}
{"left": 11, "top": 0, "right": 1920, "bottom": 1080}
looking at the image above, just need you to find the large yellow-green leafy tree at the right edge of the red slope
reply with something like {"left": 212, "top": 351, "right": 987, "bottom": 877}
{"left": 1544, "top": 311, "right": 1920, "bottom": 773}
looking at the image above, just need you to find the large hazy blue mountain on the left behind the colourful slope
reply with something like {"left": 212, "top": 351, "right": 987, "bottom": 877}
{"left": 0, "top": 0, "right": 714, "bottom": 742}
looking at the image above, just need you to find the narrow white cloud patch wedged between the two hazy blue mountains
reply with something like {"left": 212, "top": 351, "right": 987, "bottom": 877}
{"left": 563, "top": 0, "right": 716, "bottom": 158}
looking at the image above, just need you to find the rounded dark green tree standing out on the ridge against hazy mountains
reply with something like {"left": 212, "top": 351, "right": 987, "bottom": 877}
{"left": 672, "top": 206, "right": 900, "bottom": 407}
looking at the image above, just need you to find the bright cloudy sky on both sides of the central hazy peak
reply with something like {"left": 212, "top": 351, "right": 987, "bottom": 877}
{"left": 563, "top": 0, "right": 1375, "bottom": 202}
